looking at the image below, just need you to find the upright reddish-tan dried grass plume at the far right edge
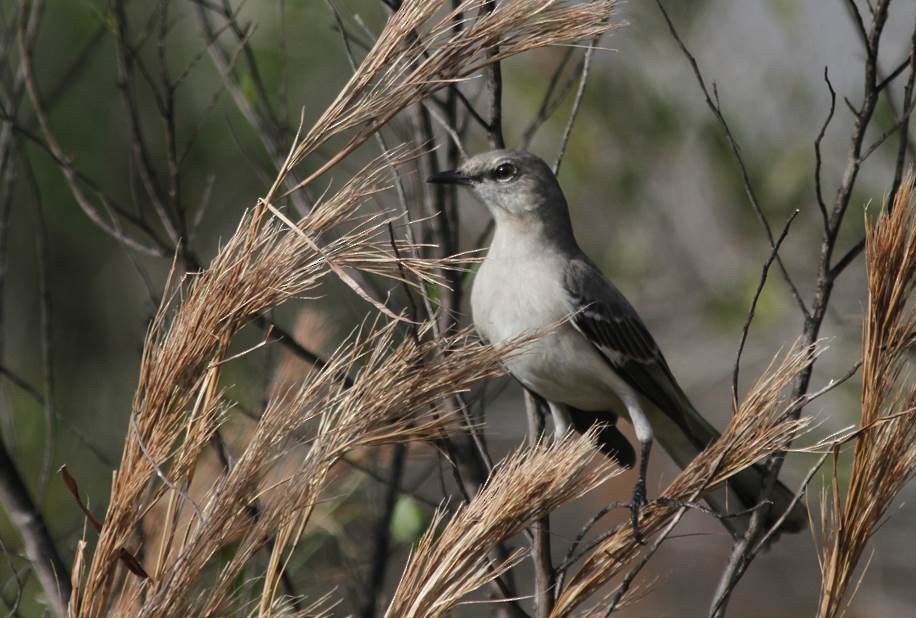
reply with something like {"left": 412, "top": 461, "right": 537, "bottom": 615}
{"left": 818, "top": 172, "right": 916, "bottom": 618}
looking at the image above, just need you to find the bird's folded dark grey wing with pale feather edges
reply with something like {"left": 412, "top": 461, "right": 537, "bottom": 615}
{"left": 564, "top": 257, "right": 706, "bottom": 442}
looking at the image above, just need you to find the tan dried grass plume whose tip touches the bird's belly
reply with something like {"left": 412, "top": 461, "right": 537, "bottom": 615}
{"left": 98, "top": 323, "right": 514, "bottom": 617}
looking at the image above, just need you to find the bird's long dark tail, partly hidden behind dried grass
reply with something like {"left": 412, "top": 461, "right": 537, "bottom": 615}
{"left": 650, "top": 398, "right": 808, "bottom": 537}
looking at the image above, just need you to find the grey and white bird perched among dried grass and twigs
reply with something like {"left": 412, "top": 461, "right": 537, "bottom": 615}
{"left": 428, "top": 149, "right": 808, "bottom": 539}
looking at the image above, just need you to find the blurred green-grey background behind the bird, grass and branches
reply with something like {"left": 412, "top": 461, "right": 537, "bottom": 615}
{"left": 0, "top": 0, "right": 916, "bottom": 617}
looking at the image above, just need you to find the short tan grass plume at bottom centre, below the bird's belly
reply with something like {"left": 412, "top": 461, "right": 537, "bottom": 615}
{"left": 385, "top": 433, "right": 620, "bottom": 618}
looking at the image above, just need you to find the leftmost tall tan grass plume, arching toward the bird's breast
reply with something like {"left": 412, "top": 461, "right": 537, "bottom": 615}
{"left": 74, "top": 150, "right": 458, "bottom": 615}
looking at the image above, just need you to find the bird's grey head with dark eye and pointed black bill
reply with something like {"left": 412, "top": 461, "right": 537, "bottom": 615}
{"left": 427, "top": 150, "right": 566, "bottom": 221}
